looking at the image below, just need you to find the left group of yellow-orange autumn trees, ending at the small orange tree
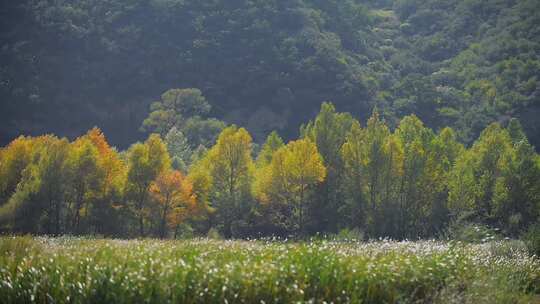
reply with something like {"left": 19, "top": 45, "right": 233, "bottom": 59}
{"left": 0, "top": 128, "right": 199, "bottom": 237}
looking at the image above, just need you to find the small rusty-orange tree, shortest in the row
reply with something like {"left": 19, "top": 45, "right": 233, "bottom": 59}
{"left": 150, "top": 170, "right": 196, "bottom": 238}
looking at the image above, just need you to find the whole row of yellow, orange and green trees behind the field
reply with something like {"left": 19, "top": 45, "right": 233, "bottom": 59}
{"left": 0, "top": 103, "right": 540, "bottom": 238}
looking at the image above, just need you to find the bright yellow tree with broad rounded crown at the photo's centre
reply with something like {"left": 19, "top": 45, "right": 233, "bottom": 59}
{"left": 257, "top": 139, "right": 326, "bottom": 234}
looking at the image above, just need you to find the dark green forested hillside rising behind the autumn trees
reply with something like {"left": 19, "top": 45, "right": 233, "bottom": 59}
{"left": 0, "top": 0, "right": 540, "bottom": 148}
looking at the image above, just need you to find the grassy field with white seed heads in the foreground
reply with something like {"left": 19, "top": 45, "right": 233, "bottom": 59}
{"left": 0, "top": 237, "right": 540, "bottom": 303}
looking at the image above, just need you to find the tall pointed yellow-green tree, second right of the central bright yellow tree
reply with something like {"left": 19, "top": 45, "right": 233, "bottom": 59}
{"left": 341, "top": 109, "right": 404, "bottom": 237}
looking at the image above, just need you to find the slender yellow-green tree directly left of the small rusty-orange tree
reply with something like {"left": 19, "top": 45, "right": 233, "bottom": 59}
{"left": 126, "top": 134, "right": 170, "bottom": 236}
